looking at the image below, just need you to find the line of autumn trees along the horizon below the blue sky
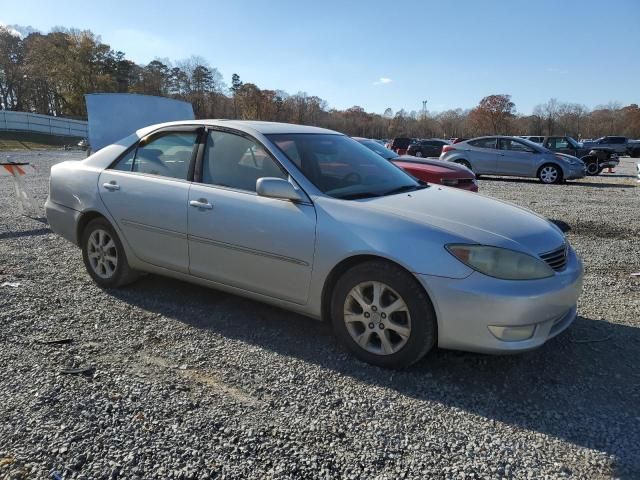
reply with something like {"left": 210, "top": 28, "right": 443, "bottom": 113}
{"left": 0, "top": 26, "right": 640, "bottom": 138}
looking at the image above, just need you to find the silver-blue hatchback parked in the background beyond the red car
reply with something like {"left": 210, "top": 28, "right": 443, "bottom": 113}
{"left": 440, "top": 136, "right": 587, "bottom": 183}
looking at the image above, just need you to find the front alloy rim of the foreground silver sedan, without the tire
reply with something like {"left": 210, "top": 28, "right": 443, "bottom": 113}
{"left": 344, "top": 281, "right": 411, "bottom": 355}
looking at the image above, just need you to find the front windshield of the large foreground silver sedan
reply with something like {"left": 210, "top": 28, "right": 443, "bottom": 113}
{"left": 267, "top": 133, "right": 423, "bottom": 199}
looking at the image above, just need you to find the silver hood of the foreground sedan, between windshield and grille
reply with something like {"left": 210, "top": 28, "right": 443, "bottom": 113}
{"left": 357, "top": 185, "right": 565, "bottom": 255}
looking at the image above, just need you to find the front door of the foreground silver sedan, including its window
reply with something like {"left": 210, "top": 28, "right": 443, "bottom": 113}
{"left": 188, "top": 130, "right": 316, "bottom": 304}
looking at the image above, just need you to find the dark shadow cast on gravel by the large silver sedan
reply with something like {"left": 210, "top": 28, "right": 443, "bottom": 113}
{"left": 109, "top": 275, "right": 640, "bottom": 478}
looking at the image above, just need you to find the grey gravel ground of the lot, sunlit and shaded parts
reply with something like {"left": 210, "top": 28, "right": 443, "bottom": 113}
{"left": 0, "top": 152, "right": 640, "bottom": 479}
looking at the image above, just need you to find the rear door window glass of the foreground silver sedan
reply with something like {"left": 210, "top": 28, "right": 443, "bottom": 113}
{"left": 132, "top": 132, "right": 198, "bottom": 180}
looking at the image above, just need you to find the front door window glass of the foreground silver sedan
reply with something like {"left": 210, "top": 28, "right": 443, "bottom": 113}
{"left": 202, "top": 131, "right": 288, "bottom": 192}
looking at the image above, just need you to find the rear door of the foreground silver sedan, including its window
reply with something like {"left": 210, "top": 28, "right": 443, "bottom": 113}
{"left": 98, "top": 127, "right": 199, "bottom": 273}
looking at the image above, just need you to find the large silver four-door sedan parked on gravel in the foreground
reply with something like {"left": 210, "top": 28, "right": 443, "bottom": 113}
{"left": 46, "top": 120, "right": 583, "bottom": 367}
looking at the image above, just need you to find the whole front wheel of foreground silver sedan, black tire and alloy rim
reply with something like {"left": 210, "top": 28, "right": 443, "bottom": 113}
{"left": 331, "top": 260, "right": 437, "bottom": 369}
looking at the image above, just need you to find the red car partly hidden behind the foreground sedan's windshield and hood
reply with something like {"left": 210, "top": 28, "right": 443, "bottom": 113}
{"left": 353, "top": 137, "right": 478, "bottom": 192}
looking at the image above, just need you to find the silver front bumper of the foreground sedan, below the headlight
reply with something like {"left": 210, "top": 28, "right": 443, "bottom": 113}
{"left": 416, "top": 248, "right": 583, "bottom": 354}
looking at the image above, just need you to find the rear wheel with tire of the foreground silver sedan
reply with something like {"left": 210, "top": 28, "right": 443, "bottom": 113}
{"left": 81, "top": 218, "right": 138, "bottom": 288}
